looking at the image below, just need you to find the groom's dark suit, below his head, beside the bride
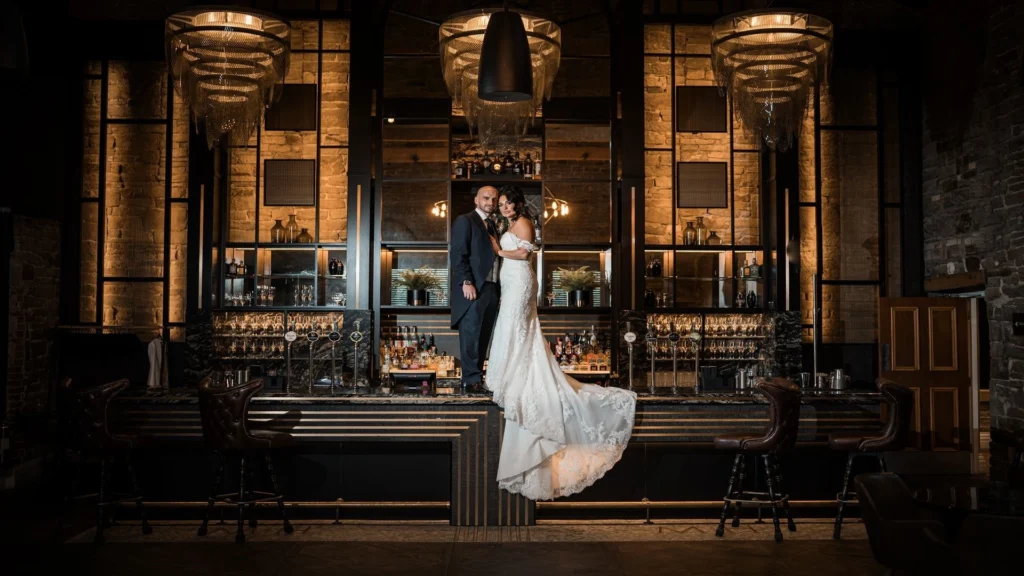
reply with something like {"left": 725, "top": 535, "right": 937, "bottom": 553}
{"left": 449, "top": 210, "right": 501, "bottom": 384}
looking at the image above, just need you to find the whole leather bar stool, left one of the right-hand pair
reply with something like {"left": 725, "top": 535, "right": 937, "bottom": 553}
{"left": 715, "top": 378, "right": 800, "bottom": 542}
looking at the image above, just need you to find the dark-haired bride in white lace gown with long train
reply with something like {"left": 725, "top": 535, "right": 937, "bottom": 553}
{"left": 486, "top": 187, "right": 636, "bottom": 500}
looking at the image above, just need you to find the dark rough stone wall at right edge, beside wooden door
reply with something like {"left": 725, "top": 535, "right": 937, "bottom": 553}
{"left": 923, "top": 0, "right": 1024, "bottom": 471}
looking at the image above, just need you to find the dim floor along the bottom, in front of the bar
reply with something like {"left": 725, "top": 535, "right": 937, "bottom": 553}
{"left": 13, "top": 520, "right": 884, "bottom": 576}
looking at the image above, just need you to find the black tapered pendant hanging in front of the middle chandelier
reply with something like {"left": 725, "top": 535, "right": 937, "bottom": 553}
{"left": 477, "top": 4, "right": 534, "bottom": 102}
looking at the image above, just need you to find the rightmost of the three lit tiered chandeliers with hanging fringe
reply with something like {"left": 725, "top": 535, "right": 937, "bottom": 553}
{"left": 712, "top": 10, "right": 833, "bottom": 152}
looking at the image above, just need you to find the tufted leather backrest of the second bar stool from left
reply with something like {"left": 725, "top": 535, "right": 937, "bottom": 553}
{"left": 199, "top": 378, "right": 269, "bottom": 451}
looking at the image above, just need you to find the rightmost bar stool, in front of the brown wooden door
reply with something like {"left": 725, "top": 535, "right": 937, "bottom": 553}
{"left": 828, "top": 378, "right": 913, "bottom": 540}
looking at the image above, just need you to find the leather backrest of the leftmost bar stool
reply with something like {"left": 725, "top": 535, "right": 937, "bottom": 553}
{"left": 60, "top": 378, "right": 133, "bottom": 458}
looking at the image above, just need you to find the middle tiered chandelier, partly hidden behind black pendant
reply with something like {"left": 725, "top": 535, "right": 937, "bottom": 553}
{"left": 437, "top": 8, "right": 562, "bottom": 149}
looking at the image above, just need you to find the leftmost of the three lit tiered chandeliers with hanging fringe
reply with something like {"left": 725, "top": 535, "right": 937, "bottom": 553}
{"left": 164, "top": 7, "right": 292, "bottom": 148}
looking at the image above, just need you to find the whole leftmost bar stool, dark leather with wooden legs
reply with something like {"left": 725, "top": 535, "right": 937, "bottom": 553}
{"left": 60, "top": 378, "right": 153, "bottom": 543}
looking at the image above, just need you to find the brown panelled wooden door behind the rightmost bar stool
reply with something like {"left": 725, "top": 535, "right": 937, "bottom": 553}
{"left": 879, "top": 298, "right": 973, "bottom": 452}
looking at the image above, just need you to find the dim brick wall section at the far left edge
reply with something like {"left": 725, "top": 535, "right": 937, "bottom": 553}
{"left": 6, "top": 215, "right": 60, "bottom": 461}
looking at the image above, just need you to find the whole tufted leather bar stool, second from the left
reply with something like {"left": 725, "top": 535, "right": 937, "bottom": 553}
{"left": 198, "top": 378, "right": 294, "bottom": 544}
